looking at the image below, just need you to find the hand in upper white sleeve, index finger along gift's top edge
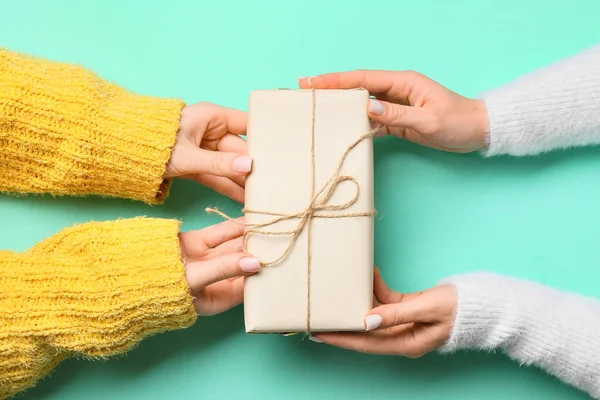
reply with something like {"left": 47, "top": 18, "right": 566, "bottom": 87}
{"left": 299, "top": 71, "right": 489, "bottom": 153}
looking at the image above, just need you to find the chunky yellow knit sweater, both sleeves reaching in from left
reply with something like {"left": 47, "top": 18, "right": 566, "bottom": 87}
{"left": 0, "top": 49, "right": 196, "bottom": 399}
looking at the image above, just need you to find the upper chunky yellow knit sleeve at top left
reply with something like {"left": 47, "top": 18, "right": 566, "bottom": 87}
{"left": 0, "top": 49, "right": 183, "bottom": 204}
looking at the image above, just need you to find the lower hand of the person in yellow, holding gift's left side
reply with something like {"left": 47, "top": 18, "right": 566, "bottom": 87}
{"left": 179, "top": 219, "right": 260, "bottom": 315}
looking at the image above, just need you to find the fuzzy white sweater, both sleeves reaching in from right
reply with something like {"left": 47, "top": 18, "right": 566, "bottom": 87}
{"left": 441, "top": 46, "right": 600, "bottom": 399}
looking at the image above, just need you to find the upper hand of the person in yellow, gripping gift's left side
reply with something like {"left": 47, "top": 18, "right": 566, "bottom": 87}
{"left": 164, "top": 103, "right": 252, "bottom": 203}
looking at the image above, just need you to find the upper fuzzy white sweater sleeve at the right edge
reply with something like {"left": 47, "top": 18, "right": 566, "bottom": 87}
{"left": 480, "top": 45, "right": 600, "bottom": 156}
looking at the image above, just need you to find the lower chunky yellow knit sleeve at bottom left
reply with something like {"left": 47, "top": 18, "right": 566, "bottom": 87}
{"left": 0, "top": 218, "right": 196, "bottom": 399}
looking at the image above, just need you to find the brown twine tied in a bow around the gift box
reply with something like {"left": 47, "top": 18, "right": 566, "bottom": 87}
{"left": 206, "top": 89, "right": 379, "bottom": 333}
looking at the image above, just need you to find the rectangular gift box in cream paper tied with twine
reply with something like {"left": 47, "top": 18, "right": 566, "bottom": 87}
{"left": 244, "top": 89, "right": 374, "bottom": 333}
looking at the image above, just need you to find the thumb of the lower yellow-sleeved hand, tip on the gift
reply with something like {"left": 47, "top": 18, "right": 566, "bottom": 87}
{"left": 185, "top": 252, "right": 260, "bottom": 292}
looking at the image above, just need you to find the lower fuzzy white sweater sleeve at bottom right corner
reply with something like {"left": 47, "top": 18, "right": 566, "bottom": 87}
{"left": 440, "top": 273, "right": 600, "bottom": 399}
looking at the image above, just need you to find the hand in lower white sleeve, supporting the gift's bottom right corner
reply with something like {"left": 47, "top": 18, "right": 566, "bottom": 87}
{"left": 311, "top": 270, "right": 458, "bottom": 358}
